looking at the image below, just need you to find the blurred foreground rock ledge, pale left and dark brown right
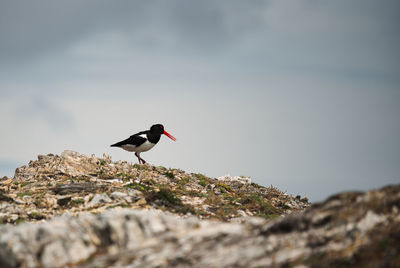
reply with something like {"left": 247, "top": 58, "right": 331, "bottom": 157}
{"left": 0, "top": 186, "right": 400, "bottom": 267}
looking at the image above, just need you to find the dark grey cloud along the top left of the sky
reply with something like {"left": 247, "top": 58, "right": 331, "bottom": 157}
{"left": 0, "top": 0, "right": 264, "bottom": 64}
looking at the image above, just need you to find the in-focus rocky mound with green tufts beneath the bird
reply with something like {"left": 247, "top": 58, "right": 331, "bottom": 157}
{"left": 0, "top": 151, "right": 310, "bottom": 223}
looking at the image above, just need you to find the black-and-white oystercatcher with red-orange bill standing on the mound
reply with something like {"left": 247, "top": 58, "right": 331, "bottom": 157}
{"left": 111, "top": 124, "right": 176, "bottom": 164}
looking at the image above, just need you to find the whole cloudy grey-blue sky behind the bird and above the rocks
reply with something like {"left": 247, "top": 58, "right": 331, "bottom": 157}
{"left": 0, "top": 0, "right": 400, "bottom": 202}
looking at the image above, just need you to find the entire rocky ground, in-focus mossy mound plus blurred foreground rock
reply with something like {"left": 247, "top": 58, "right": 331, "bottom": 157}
{"left": 0, "top": 153, "right": 400, "bottom": 267}
